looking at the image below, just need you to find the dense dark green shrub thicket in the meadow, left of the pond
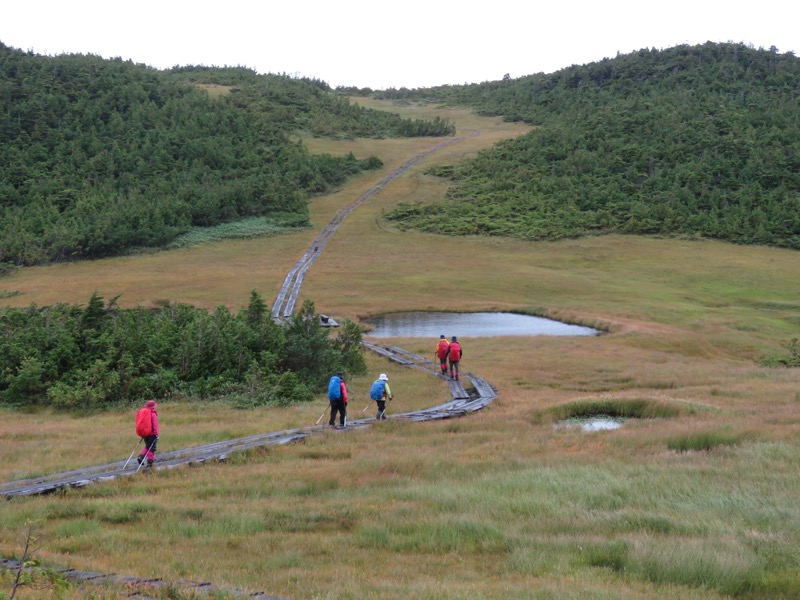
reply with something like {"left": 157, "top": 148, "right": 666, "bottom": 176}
{"left": 0, "top": 291, "right": 366, "bottom": 408}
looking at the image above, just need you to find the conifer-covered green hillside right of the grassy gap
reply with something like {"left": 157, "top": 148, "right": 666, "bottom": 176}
{"left": 381, "top": 43, "right": 800, "bottom": 249}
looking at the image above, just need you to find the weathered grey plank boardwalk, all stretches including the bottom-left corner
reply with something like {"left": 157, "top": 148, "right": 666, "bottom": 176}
{"left": 0, "top": 132, "right": 496, "bottom": 600}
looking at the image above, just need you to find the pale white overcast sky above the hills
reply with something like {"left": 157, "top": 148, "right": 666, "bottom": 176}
{"left": 0, "top": 0, "right": 800, "bottom": 89}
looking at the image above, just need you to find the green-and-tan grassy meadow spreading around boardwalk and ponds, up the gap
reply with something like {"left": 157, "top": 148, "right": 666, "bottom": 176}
{"left": 0, "top": 101, "right": 800, "bottom": 600}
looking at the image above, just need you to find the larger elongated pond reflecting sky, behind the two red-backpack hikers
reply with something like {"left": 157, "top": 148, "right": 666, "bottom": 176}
{"left": 366, "top": 312, "right": 599, "bottom": 339}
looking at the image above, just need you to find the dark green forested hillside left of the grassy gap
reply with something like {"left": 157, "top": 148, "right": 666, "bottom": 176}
{"left": 0, "top": 43, "right": 454, "bottom": 265}
